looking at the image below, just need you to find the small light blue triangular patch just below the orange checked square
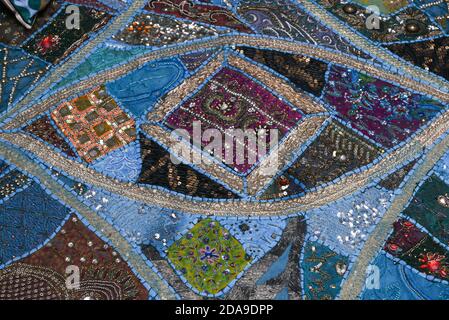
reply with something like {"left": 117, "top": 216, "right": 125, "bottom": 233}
{"left": 91, "top": 141, "right": 142, "bottom": 182}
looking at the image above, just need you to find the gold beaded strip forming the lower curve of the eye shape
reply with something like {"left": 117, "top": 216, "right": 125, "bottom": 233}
{"left": 0, "top": 119, "right": 432, "bottom": 216}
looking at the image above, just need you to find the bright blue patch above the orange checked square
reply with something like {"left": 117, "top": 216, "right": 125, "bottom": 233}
{"left": 106, "top": 59, "right": 185, "bottom": 117}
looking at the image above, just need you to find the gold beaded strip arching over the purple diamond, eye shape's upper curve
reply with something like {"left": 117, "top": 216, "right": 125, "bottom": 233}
{"left": 2, "top": 34, "right": 449, "bottom": 130}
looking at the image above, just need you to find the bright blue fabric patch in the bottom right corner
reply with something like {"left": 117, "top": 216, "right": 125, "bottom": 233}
{"left": 362, "top": 253, "right": 449, "bottom": 300}
